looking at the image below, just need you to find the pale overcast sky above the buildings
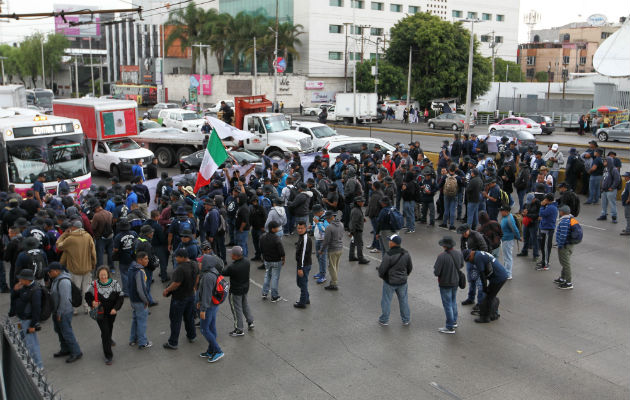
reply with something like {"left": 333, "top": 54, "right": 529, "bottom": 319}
{"left": 0, "top": 0, "right": 630, "bottom": 43}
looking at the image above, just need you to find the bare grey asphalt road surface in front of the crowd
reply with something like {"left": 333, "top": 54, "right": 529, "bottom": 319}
{"left": 0, "top": 188, "right": 630, "bottom": 400}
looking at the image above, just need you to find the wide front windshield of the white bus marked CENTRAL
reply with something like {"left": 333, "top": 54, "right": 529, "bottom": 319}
{"left": 6, "top": 134, "right": 89, "bottom": 183}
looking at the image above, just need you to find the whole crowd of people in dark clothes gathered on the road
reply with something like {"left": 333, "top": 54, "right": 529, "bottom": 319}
{"left": 0, "top": 135, "right": 630, "bottom": 367}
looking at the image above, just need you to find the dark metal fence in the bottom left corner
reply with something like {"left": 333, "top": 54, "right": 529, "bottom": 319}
{"left": 0, "top": 318, "right": 61, "bottom": 400}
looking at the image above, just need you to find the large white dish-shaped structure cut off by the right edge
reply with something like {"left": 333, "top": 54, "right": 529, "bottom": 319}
{"left": 593, "top": 21, "right": 630, "bottom": 77}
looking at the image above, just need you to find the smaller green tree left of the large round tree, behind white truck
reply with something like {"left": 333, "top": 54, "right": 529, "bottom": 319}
{"left": 357, "top": 59, "right": 407, "bottom": 98}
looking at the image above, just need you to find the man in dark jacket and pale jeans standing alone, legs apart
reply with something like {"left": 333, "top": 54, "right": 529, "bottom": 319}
{"left": 377, "top": 234, "right": 413, "bottom": 326}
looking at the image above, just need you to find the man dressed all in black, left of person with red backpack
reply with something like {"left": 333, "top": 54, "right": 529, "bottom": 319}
{"left": 162, "top": 249, "right": 199, "bottom": 350}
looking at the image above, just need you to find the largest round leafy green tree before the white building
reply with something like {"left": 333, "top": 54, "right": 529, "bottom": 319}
{"left": 386, "top": 13, "right": 492, "bottom": 106}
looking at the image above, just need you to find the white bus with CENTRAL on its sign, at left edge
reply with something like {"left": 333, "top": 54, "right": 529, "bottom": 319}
{"left": 0, "top": 108, "right": 92, "bottom": 195}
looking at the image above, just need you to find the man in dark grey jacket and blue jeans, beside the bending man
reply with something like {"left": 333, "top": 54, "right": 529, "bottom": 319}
{"left": 433, "top": 236, "right": 464, "bottom": 334}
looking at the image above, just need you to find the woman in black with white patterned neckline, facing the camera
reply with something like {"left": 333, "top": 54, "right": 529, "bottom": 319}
{"left": 85, "top": 265, "right": 125, "bottom": 365}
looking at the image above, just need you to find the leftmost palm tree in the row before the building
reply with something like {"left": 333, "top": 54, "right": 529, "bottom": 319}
{"left": 164, "top": 2, "right": 206, "bottom": 74}
